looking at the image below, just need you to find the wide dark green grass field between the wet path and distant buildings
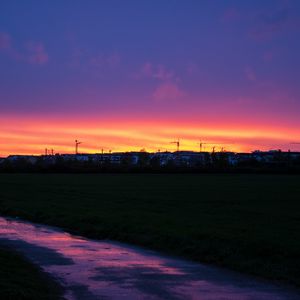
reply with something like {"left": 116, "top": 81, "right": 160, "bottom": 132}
{"left": 0, "top": 174, "right": 300, "bottom": 286}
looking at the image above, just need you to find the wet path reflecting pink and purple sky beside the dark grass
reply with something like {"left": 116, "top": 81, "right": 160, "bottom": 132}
{"left": 0, "top": 217, "right": 300, "bottom": 300}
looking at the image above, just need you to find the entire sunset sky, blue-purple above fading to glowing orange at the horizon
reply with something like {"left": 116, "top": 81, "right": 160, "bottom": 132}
{"left": 0, "top": 0, "right": 300, "bottom": 156}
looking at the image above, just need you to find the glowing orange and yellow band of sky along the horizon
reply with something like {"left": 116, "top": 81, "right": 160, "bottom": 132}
{"left": 0, "top": 117, "right": 300, "bottom": 157}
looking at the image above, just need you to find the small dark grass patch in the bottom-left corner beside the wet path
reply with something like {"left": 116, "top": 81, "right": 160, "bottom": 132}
{"left": 0, "top": 248, "right": 63, "bottom": 300}
